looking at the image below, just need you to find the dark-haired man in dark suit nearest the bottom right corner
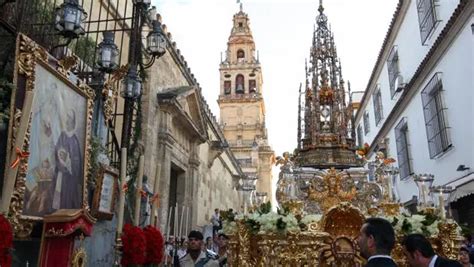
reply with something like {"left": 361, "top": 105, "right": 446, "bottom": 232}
{"left": 402, "top": 234, "right": 462, "bottom": 267}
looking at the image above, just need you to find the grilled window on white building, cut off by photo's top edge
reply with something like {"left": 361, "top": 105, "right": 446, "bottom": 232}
{"left": 416, "top": 0, "right": 438, "bottom": 45}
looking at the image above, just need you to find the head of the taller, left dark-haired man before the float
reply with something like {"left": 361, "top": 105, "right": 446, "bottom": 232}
{"left": 357, "top": 218, "right": 395, "bottom": 259}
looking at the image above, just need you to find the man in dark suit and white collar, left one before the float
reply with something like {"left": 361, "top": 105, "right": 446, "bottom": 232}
{"left": 357, "top": 218, "right": 397, "bottom": 267}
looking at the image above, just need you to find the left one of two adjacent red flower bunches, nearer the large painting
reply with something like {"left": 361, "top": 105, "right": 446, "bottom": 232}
{"left": 122, "top": 224, "right": 146, "bottom": 266}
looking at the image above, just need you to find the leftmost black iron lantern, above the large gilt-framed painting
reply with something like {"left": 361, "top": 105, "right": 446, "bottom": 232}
{"left": 55, "top": 0, "right": 87, "bottom": 38}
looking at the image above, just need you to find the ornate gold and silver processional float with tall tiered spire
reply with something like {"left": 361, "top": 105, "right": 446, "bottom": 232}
{"left": 224, "top": 3, "right": 459, "bottom": 267}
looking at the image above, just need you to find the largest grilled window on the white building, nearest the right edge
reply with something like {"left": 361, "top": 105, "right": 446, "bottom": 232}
{"left": 421, "top": 72, "right": 452, "bottom": 158}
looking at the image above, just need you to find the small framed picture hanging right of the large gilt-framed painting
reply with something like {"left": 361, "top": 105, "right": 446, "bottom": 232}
{"left": 91, "top": 164, "right": 119, "bottom": 220}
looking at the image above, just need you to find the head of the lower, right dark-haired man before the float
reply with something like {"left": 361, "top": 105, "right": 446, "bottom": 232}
{"left": 402, "top": 234, "right": 435, "bottom": 267}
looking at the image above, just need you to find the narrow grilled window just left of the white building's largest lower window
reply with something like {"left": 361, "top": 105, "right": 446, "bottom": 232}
{"left": 395, "top": 118, "right": 412, "bottom": 179}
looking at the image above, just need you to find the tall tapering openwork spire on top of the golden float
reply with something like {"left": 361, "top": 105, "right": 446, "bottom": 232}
{"left": 295, "top": 1, "right": 362, "bottom": 169}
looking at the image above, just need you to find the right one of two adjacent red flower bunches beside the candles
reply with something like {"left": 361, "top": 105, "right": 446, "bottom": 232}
{"left": 143, "top": 225, "right": 165, "bottom": 264}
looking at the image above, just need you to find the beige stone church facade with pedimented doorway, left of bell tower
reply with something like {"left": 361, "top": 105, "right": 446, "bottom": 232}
{"left": 141, "top": 23, "right": 243, "bottom": 235}
